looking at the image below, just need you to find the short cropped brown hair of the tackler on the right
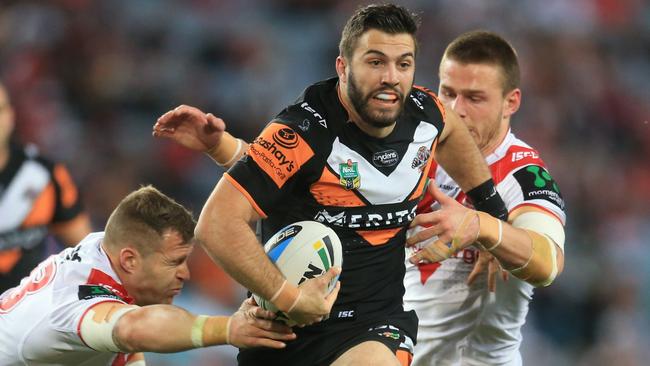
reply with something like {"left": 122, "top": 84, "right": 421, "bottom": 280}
{"left": 443, "top": 30, "right": 521, "bottom": 94}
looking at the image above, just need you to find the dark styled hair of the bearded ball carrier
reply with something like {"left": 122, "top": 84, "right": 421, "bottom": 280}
{"left": 339, "top": 4, "right": 419, "bottom": 59}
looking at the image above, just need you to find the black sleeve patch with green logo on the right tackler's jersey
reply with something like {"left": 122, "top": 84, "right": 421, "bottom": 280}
{"left": 514, "top": 165, "right": 564, "bottom": 210}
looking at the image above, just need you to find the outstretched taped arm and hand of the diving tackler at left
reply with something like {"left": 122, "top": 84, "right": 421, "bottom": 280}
{"left": 80, "top": 300, "right": 295, "bottom": 353}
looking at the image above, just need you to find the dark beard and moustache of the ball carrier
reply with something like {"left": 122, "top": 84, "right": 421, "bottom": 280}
{"left": 348, "top": 70, "right": 410, "bottom": 128}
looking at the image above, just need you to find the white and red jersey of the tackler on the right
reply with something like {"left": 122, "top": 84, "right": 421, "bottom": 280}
{"left": 404, "top": 132, "right": 566, "bottom": 366}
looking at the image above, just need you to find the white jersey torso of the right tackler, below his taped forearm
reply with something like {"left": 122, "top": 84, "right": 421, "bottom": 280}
{"left": 404, "top": 249, "right": 533, "bottom": 366}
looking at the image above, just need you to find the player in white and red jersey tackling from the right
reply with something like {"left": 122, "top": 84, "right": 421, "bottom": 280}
{"left": 404, "top": 31, "right": 566, "bottom": 366}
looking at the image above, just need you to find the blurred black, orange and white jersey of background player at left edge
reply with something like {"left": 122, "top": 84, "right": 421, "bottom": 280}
{"left": 0, "top": 144, "right": 82, "bottom": 293}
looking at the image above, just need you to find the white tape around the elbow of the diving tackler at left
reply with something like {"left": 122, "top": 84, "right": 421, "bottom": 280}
{"left": 79, "top": 305, "right": 139, "bottom": 352}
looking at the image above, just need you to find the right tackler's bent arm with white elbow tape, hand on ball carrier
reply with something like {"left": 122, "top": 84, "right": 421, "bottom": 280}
{"left": 407, "top": 185, "right": 564, "bottom": 286}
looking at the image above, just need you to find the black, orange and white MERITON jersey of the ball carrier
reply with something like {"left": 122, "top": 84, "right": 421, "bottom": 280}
{"left": 225, "top": 78, "right": 444, "bottom": 332}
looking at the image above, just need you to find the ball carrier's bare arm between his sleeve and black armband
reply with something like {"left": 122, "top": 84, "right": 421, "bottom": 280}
{"left": 436, "top": 108, "right": 492, "bottom": 192}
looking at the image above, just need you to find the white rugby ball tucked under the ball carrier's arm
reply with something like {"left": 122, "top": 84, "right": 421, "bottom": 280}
{"left": 253, "top": 221, "right": 343, "bottom": 321}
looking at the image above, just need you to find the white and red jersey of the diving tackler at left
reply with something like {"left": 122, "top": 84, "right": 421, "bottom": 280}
{"left": 0, "top": 233, "right": 132, "bottom": 366}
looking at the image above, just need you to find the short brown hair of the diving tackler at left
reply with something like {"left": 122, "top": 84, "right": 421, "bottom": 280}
{"left": 104, "top": 186, "right": 196, "bottom": 253}
